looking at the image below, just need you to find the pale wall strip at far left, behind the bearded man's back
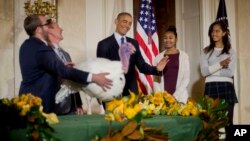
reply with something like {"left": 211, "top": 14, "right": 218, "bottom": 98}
{"left": 0, "top": 0, "right": 15, "bottom": 98}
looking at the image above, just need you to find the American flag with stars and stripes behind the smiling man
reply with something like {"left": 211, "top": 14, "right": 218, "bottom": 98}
{"left": 135, "top": 0, "right": 159, "bottom": 94}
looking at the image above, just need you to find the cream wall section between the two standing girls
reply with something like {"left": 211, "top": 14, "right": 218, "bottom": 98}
{"left": 176, "top": 0, "right": 203, "bottom": 99}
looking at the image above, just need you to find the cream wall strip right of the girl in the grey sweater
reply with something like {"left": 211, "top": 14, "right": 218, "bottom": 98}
{"left": 234, "top": 0, "right": 250, "bottom": 124}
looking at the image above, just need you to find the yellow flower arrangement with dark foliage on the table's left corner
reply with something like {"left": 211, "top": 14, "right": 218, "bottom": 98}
{"left": 0, "top": 93, "right": 59, "bottom": 141}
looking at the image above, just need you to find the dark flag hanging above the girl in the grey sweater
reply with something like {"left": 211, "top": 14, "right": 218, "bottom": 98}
{"left": 216, "top": 0, "right": 228, "bottom": 26}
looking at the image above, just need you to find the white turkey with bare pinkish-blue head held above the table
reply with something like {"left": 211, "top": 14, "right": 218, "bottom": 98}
{"left": 56, "top": 43, "right": 135, "bottom": 103}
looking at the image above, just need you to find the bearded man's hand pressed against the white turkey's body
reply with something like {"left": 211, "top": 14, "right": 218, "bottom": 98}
{"left": 92, "top": 73, "right": 113, "bottom": 91}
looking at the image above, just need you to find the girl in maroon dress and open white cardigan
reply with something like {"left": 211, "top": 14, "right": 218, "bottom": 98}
{"left": 154, "top": 26, "right": 190, "bottom": 103}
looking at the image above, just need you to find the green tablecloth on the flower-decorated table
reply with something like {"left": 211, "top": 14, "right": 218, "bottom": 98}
{"left": 12, "top": 115, "right": 202, "bottom": 141}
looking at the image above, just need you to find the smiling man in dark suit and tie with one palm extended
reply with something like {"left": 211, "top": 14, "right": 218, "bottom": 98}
{"left": 97, "top": 12, "right": 168, "bottom": 96}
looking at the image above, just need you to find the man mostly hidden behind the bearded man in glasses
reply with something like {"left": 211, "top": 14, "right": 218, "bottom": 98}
{"left": 48, "top": 21, "right": 84, "bottom": 115}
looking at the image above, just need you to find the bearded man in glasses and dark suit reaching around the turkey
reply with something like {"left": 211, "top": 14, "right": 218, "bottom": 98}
{"left": 19, "top": 15, "right": 112, "bottom": 112}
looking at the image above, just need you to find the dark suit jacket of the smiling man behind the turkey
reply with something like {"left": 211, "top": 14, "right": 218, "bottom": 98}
{"left": 97, "top": 34, "right": 160, "bottom": 96}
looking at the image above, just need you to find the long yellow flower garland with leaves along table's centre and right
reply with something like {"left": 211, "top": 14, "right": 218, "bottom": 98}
{"left": 98, "top": 91, "right": 227, "bottom": 141}
